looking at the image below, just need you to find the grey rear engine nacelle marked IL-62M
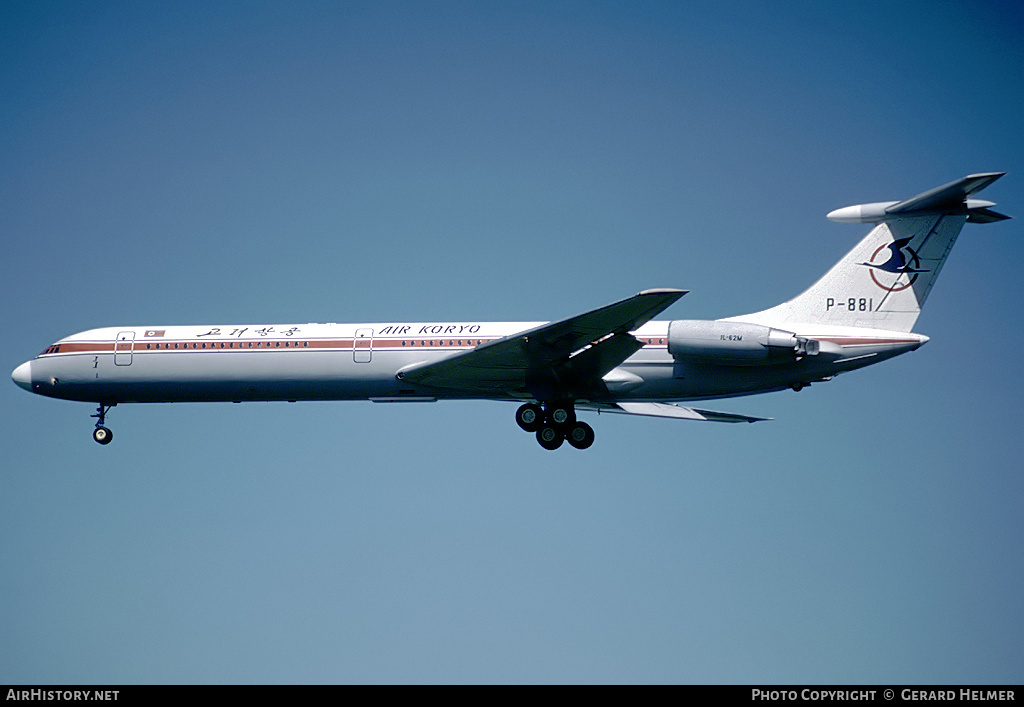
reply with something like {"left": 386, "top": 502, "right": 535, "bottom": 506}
{"left": 669, "top": 320, "right": 819, "bottom": 366}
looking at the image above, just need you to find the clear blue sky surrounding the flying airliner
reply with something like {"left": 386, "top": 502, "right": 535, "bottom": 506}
{"left": 0, "top": 2, "right": 1024, "bottom": 683}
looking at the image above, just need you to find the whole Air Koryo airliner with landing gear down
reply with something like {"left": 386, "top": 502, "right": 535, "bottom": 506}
{"left": 11, "top": 172, "right": 1010, "bottom": 450}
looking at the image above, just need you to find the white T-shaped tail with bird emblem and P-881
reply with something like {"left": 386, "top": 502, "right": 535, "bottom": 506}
{"left": 730, "top": 172, "right": 1010, "bottom": 332}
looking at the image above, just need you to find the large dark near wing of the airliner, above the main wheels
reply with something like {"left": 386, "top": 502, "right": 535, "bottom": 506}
{"left": 398, "top": 289, "right": 686, "bottom": 397}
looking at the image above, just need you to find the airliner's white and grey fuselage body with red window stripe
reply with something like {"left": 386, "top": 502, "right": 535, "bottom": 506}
{"left": 14, "top": 321, "right": 928, "bottom": 405}
